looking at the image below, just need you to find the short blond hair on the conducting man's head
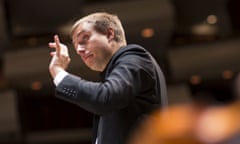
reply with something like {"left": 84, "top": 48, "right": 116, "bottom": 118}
{"left": 71, "top": 12, "right": 126, "bottom": 45}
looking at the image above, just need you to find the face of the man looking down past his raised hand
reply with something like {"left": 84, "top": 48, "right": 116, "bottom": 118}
{"left": 72, "top": 23, "right": 113, "bottom": 71}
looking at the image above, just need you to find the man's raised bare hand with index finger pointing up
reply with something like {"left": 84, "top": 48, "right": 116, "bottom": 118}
{"left": 48, "top": 35, "right": 71, "bottom": 78}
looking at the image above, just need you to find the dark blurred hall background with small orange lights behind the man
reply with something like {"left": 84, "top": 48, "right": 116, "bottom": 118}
{"left": 0, "top": 0, "right": 240, "bottom": 144}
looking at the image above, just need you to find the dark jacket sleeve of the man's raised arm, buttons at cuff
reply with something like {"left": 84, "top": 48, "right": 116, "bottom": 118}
{"left": 56, "top": 57, "right": 156, "bottom": 115}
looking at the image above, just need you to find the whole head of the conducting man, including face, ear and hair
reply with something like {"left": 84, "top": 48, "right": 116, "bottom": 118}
{"left": 71, "top": 12, "right": 126, "bottom": 71}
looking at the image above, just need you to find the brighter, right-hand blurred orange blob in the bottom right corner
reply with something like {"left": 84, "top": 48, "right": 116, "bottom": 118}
{"left": 196, "top": 103, "right": 239, "bottom": 143}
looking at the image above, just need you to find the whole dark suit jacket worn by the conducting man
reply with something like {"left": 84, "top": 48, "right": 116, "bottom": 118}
{"left": 56, "top": 45, "right": 167, "bottom": 144}
